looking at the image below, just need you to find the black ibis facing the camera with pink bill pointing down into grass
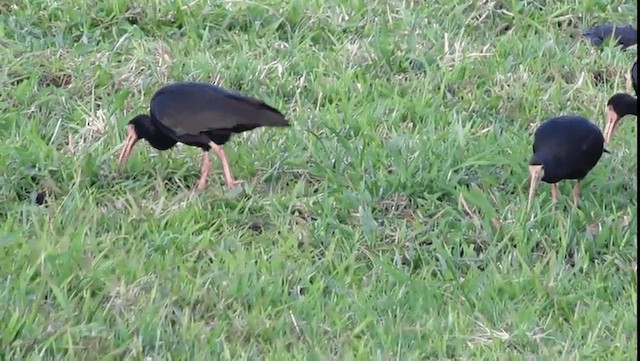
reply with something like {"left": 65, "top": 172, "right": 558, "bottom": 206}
{"left": 528, "top": 115, "right": 608, "bottom": 207}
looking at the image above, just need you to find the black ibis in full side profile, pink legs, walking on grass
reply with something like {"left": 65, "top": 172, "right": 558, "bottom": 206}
{"left": 118, "top": 82, "right": 289, "bottom": 190}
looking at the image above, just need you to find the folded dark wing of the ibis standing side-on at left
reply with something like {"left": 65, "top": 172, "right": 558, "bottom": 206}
{"left": 151, "top": 83, "right": 288, "bottom": 135}
